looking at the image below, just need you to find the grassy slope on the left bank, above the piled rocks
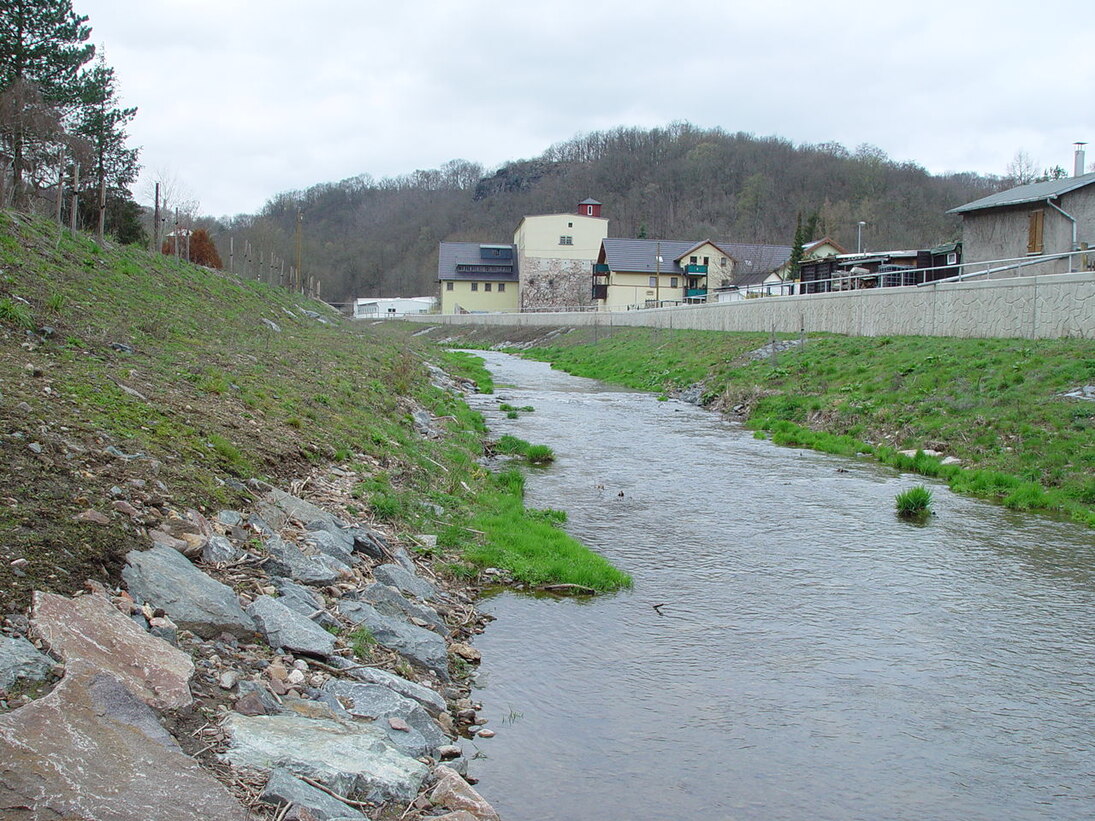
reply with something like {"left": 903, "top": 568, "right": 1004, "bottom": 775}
{"left": 0, "top": 212, "right": 630, "bottom": 612}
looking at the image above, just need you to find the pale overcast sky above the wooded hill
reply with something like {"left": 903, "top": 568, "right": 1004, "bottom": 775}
{"left": 73, "top": 0, "right": 1095, "bottom": 216}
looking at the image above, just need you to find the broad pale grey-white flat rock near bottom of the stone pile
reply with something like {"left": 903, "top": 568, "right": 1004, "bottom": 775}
{"left": 223, "top": 714, "right": 428, "bottom": 803}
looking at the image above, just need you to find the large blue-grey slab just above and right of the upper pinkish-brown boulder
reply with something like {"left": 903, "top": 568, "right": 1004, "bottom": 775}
{"left": 122, "top": 546, "right": 255, "bottom": 638}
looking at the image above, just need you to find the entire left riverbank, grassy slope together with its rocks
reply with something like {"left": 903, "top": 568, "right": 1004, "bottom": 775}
{"left": 0, "top": 212, "right": 617, "bottom": 819}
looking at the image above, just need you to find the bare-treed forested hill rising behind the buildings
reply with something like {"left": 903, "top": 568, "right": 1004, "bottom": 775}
{"left": 217, "top": 124, "right": 1003, "bottom": 302}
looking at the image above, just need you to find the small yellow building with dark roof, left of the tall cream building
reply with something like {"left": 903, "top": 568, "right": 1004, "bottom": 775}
{"left": 437, "top": 242, "right": 519, "bottom": 313}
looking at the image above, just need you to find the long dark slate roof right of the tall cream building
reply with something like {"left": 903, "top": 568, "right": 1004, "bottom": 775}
{"left": 601, "top": 238, "right": 791, "bottom": 285}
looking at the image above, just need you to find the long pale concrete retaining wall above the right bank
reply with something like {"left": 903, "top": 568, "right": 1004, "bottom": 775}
{"left": 406, "top": 271, "right": 1095, "bottom": 339}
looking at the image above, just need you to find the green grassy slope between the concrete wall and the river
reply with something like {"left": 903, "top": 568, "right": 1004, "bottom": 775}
{"left": 479, "top": 328, "right": 1095, "bottom": 527}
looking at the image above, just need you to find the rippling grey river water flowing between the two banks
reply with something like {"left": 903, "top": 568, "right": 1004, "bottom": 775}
{"left": 465, "top": 352, "right": 1095, "bottom": 821}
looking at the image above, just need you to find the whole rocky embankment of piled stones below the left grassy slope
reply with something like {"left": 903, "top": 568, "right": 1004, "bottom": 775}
{"left": 0, "top": 469, "right": 497, "bottom": 821}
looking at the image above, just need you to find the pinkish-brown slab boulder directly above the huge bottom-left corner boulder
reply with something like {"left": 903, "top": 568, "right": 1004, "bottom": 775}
{"left": 31, "top": 592, "right": 194, "bottom": 709}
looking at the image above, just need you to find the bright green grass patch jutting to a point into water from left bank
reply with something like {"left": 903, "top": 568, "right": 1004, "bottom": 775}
{"left": 463, "top": 471, "right": 631, "bottom": 591}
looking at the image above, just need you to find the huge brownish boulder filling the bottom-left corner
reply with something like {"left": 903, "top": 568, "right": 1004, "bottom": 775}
{"left": 0, "top": 664, "right": 249, "bottom": 821}
